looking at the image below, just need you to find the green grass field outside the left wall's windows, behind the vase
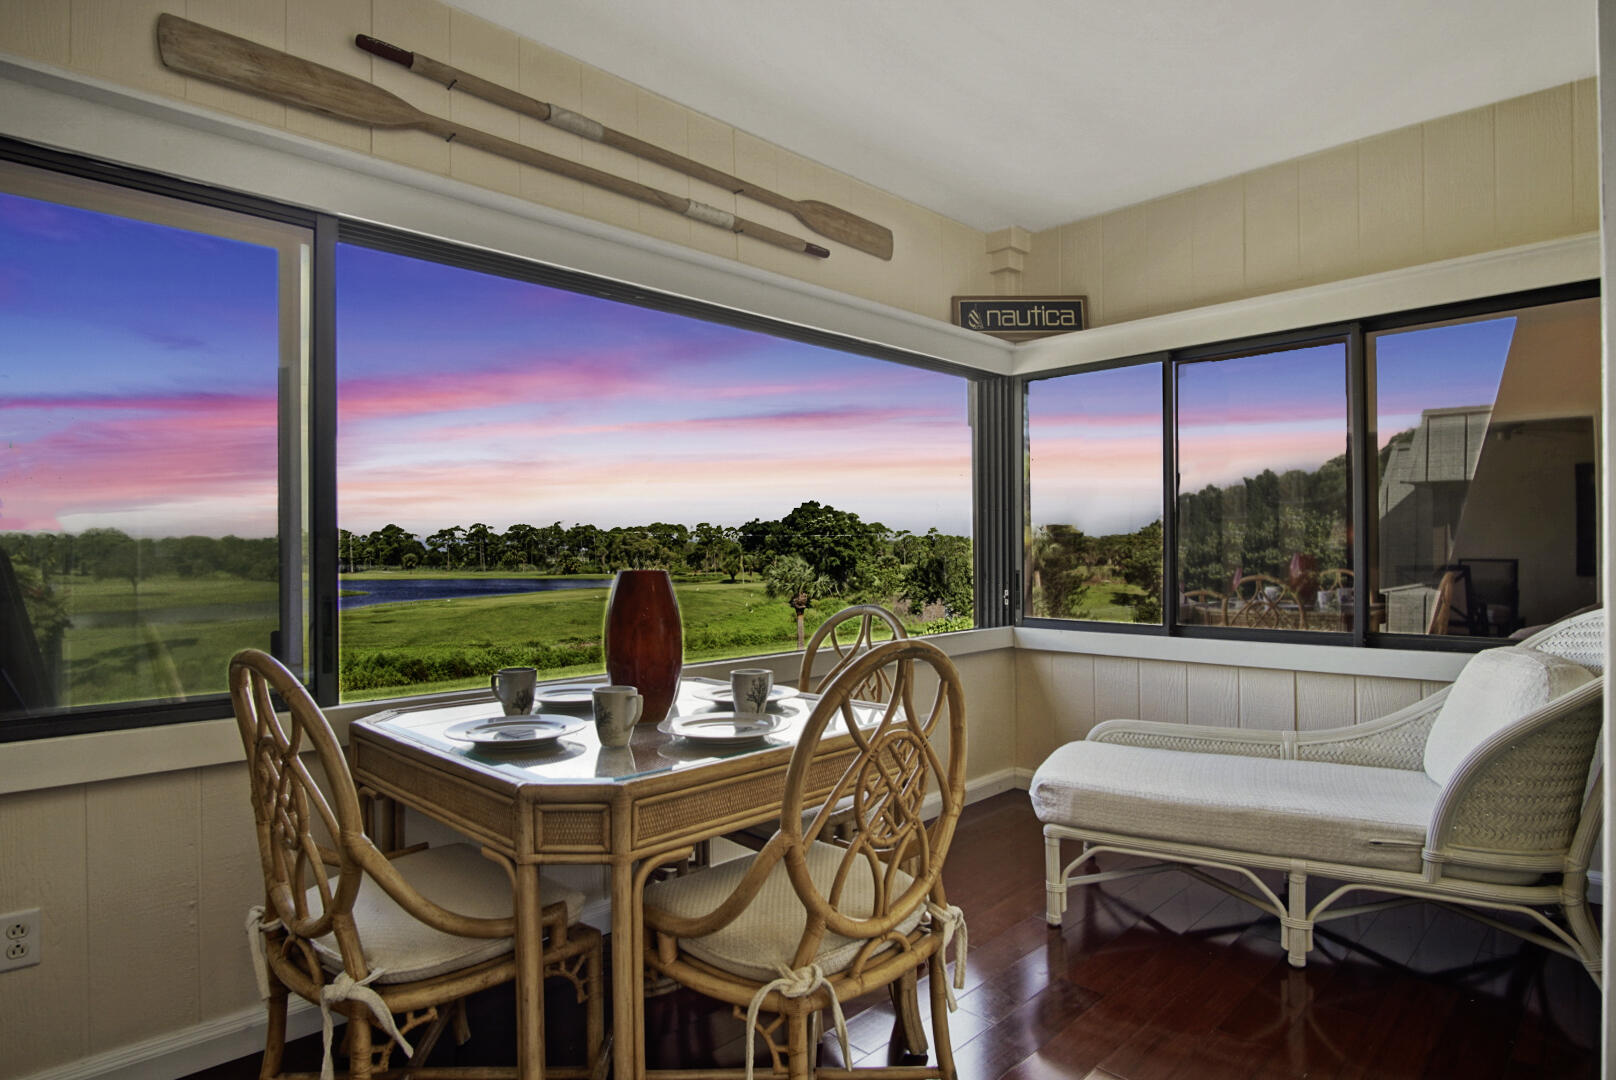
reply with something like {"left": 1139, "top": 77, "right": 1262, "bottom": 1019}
{"left": 37, "top": 571, "right": 937, "bottom": 705}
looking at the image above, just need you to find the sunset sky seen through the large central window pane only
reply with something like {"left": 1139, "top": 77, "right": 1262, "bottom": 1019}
{"left": 338, "top": 246, "right": 971, "bottom": 534}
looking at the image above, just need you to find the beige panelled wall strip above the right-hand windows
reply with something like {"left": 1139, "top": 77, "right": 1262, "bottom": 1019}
{"left": 1020, "top": 79, "right": 1598, "bottom": 327}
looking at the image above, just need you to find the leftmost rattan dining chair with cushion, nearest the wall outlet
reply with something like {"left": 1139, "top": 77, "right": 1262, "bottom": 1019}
{"left": 229, "top": 648, "right": 606, "bottom": 1080}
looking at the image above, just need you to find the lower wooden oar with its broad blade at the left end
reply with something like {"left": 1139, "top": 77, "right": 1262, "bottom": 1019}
{"left": 157, "top": 15, "right": 831, "bottom": 259}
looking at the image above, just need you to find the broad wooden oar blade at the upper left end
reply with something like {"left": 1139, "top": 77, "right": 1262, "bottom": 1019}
{"left": 157, "top": 13, "right": 422, "bottom": 128}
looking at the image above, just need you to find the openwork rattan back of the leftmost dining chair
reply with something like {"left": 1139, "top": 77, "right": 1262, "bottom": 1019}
{"left": 229, "top": 648, "right": 364, "bottom": 977}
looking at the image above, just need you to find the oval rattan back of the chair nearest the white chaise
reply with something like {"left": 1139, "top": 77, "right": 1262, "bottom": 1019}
{"left": 771, "top": 639, "right": 965, "bottom": 967}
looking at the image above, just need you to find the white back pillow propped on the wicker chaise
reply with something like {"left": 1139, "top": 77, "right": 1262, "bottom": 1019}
{"left": 1425, "top": 645, "right": 1593, "bottom": 784}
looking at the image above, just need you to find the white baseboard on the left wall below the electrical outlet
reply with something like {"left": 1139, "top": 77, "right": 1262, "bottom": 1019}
{"left": 21, "top": 998, "right": 328, "bottom": 1080}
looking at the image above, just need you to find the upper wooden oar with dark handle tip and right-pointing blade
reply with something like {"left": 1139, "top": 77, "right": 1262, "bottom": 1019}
{"left": 354, "top": 34, "right": 892, "bottom": 259}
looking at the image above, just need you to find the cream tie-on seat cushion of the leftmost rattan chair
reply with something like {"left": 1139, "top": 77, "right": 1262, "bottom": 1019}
{"left": 309, "top": 844, "right": 583, "bottom": 983}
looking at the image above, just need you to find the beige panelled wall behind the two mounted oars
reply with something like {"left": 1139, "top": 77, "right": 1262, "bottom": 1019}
{"left": 0, "top": 0, "right": 994, "bottom": 322}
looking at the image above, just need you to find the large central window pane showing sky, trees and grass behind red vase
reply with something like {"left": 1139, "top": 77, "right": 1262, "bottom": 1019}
{"left": 336, "top": 243, "right": 973, "bottom": 700}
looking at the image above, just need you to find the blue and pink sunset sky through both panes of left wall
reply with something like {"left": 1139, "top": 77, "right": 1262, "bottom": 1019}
{"left": 0, "top": 194, "right": 971, "bottom": 537}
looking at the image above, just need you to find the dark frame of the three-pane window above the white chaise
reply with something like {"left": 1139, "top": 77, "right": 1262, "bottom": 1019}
{"left": 1015, "top": 280, "right": 1600, "bottom": 653}
